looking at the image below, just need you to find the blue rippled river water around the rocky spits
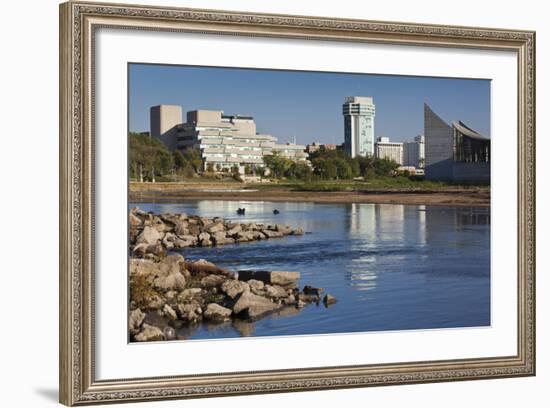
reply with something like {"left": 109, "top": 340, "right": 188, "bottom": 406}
{"left": 130, "top": 200, "right": 491, "bottom": 339}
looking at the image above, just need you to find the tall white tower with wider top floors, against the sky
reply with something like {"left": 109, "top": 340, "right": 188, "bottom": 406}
{"left": 342, "top": 96, "right": 375, "bottom": 157}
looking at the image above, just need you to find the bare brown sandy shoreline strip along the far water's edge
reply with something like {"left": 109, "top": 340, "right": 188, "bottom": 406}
{"left": 129, "top": 182, "right": 491, "bottom": 207}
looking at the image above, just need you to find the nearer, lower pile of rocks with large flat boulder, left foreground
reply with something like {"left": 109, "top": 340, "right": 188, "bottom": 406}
{"left": 128, "top": 254, "right": 336, "bottom": 341}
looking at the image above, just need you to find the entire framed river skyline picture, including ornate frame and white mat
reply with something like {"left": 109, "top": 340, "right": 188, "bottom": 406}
{"left": 60, "top": 2, "right": 535, "bottom": 405}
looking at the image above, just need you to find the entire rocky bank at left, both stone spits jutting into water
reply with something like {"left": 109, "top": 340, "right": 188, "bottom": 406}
{"left": 128, "top": 209, "right": 335, "bottom": 341}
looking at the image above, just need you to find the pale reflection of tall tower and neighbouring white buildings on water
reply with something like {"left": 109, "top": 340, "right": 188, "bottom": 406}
{"left": 348, "top": 203, "right": 427, "bottom": 291}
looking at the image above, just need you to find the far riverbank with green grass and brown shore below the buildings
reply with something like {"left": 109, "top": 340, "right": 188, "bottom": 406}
{"left": 130, "top": 177, "right": 491, "bottom": 207}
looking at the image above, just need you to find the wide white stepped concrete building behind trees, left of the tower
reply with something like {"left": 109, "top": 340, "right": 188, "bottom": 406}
{"left": 151, "top": 105, "right": 308, "bottom": 173}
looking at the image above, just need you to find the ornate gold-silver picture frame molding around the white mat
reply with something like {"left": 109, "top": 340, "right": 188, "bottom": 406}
{"left": 59, "top": 2, "right": 535, "bottom": 405}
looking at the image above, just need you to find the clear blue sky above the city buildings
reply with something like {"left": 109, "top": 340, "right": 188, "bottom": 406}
{"left": 129, "top": 64, "right": 490, "bottom": 144}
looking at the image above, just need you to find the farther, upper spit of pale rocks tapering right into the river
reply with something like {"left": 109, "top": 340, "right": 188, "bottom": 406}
{"left": 129, "top": 208, "right": 304, "bottom": 259}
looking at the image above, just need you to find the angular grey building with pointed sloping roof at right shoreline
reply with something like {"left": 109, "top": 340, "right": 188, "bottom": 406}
{"left": 424, "top": 104, "right": 491, "bottom": 183}
